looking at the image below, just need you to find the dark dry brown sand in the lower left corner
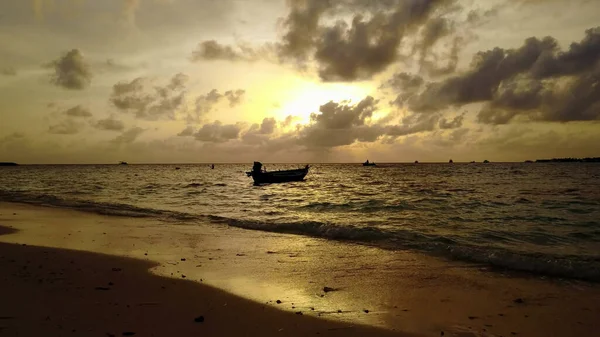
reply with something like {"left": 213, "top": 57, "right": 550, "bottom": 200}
{"left": 0, "top": 236, "right": 409, "bottom": 336}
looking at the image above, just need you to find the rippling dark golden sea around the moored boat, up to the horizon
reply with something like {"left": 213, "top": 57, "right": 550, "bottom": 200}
{"left": 0, "top": 163, "right": 600, "bottom": 281}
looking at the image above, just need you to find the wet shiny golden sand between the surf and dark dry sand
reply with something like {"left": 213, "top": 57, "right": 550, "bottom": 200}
{"left": 0, "top": 203, "right": 600, "bottom": 337}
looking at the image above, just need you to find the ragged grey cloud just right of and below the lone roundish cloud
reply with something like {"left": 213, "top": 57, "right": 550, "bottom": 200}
{"left": 110, "top": 73, "right": 189, "bottom": 120}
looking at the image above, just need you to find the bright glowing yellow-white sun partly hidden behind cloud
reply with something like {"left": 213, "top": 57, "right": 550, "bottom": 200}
{"left": 273, "top": 81, "right": 372, "bottom": 124}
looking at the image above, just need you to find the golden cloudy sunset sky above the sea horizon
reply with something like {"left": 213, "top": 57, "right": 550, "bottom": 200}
{"left": 0, "top": 0, "right": 600, "bottom": 164}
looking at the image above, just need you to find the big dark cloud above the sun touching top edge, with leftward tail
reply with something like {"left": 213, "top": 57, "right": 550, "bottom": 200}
{"left": 197, "top": 0, "right": 457, "bottom": 81}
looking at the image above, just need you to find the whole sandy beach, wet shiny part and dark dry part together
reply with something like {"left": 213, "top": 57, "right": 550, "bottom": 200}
{"left": 0, "top": 203, "right": 600, "bottom": 337}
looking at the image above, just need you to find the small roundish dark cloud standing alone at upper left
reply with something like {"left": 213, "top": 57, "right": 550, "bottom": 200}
{"left": 48, "top": 49, "right": 92, "bottom": 90}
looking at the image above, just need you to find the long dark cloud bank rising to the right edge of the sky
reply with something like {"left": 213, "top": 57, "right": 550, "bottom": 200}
{"left": 390, "top": 27, "right": 600, "bottom": 124}
